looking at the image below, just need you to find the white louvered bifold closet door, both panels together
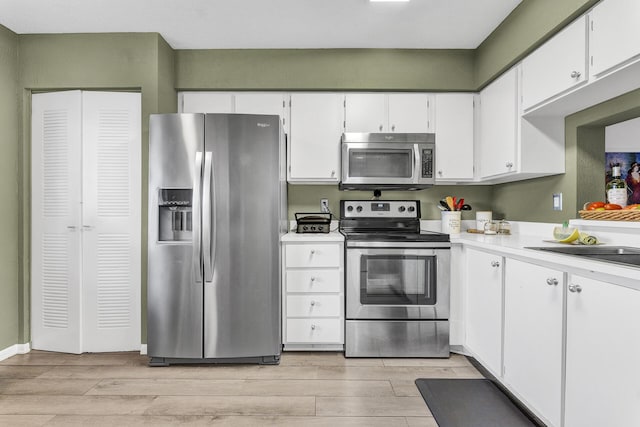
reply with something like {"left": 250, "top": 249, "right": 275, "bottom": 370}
{"left": 32, "top": 91, "right": 141, "bottom": 353}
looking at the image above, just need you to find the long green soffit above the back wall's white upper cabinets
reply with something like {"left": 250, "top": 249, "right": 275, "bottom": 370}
{"left": 176, "top": 49, "right": 475, "bottom": 91}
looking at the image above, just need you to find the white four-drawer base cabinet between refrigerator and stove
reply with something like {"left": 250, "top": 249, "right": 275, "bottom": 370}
{"left": 282, "top": 236, "right": 344, "bottom": 350}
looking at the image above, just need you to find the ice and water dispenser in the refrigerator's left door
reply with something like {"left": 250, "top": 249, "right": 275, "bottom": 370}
{"left": 158, "top": 188, "right": 193, "bottom": 241}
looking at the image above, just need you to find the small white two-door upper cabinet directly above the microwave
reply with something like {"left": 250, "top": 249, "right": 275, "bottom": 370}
{"left": 345, "top": 93, "right": 433, "bottom": 133}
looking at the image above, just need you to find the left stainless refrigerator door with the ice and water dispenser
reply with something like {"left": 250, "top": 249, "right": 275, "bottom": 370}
{"left": 147, "top": 114, "right": 204, "bottom": 358}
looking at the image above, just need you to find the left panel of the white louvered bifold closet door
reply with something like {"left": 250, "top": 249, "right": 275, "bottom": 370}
{"left": 31, "top": 91, "right": 82, "bottom": 353}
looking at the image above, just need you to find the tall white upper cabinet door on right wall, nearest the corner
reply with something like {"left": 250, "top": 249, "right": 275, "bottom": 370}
{"left": 478, "top": 68, "right": 519, "bottom": 178}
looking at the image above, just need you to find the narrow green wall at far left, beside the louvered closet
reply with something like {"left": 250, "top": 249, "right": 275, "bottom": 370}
{"left": 0, "top": 26, "right": 19, "bottom": 350}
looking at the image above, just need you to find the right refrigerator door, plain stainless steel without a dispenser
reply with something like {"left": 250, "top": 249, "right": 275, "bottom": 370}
{"left": 203, "top": 114, "right": 282, "bottom": 358}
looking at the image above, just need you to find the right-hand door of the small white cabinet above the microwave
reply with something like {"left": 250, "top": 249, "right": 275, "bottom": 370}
{"left": 388, "top": 93, "right": 432, "bottom": 133}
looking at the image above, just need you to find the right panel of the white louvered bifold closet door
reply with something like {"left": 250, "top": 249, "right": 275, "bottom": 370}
{"left": 82, "top": 92, "right": 141, "bottom": 352}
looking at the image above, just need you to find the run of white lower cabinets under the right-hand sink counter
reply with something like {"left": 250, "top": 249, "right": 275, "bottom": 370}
{"left": 463, "top": 246, "right": 640, "bottom": 427}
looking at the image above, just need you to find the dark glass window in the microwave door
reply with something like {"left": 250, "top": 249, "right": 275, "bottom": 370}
{"left": 349, "top": 148, "right": 413, "bottom": 178}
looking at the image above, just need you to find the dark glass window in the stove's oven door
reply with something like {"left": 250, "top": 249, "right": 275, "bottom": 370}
{"left": 360, "top": 255, "right": 437, "bottom": 305}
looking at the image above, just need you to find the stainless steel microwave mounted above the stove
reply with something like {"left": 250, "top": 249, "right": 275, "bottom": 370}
{"left": 339, "top": 132, "right": 436, "bottom": 190}
